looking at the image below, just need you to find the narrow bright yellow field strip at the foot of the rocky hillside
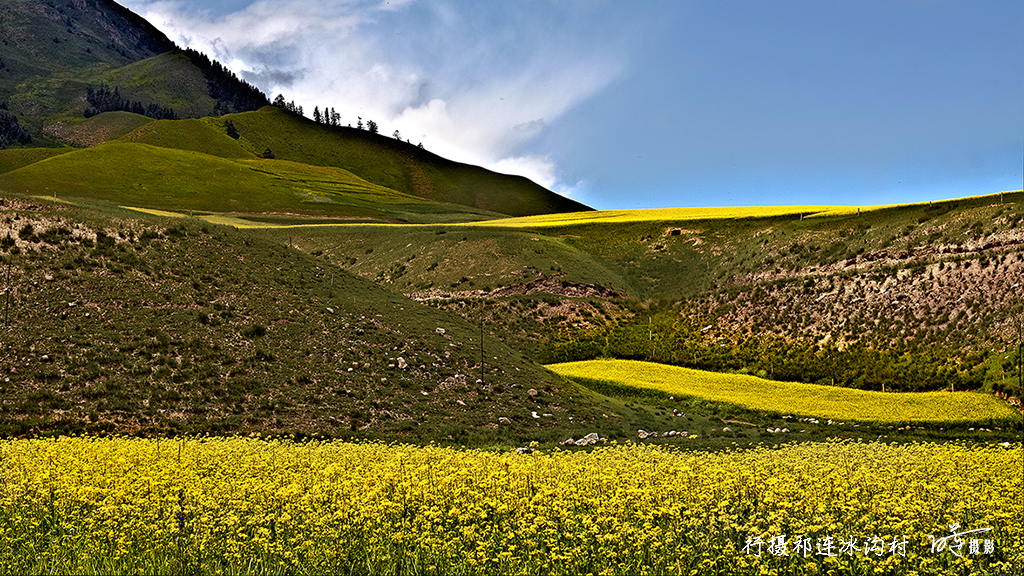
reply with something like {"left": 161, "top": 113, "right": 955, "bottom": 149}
{"left": 548, "top": 360, "right": 1017, "bottom": 422}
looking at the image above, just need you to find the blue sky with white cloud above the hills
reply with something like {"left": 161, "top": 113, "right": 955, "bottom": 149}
{"left": 122, "top": 0, "right": 1024, "bottom": 209}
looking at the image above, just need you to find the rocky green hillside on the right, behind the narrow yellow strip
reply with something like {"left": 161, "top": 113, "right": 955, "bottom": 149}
{"left": 265, "top": 192, "right": 1024, "bottom": 396}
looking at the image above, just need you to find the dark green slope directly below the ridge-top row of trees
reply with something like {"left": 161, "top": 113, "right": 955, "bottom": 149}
{"left": 34, "top": 106, "right": 589, "bottom": 216}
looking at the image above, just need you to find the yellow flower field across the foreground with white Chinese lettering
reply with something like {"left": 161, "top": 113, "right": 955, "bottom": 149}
{"left": 0, "top": 438, "right": 1024, "bottom": 575}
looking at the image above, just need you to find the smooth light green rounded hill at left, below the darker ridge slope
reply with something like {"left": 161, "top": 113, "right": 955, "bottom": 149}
{"left": 0, "top": 140, "right": 507, "bottom": 221}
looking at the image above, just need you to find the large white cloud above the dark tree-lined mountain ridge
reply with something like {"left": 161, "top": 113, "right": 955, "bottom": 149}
{"left": 119, "top": 0, "right": 625, "bottom": 191}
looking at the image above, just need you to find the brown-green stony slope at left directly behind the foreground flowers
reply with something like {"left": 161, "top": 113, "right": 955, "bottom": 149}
{"left": 0, "top": 198, "right": 622, "bottom": 443}
